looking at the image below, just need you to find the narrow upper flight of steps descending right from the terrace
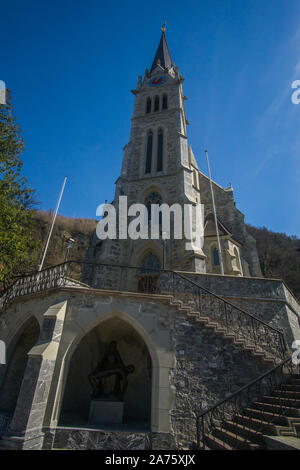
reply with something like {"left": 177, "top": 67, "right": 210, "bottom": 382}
{"left": 170, "top": 299, "right": 281, "bottom": 365}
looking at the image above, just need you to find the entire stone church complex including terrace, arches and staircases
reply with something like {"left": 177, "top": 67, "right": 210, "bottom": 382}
{"left": 0, "top": 27, "right": 300, "bottom": 450}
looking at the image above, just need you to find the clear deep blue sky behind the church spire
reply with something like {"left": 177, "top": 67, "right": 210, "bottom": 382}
{"left": 0, "top": 0, "right": 300, "bottom": 236}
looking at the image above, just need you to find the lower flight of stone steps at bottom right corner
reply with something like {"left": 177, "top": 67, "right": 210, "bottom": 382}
{"left": 203, "top": 374, "right": 300, "bottom": 450}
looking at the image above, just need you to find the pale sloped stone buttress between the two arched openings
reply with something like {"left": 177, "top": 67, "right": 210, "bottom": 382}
{"left": 1, "top": 301, "right": 67, "bottom": 449}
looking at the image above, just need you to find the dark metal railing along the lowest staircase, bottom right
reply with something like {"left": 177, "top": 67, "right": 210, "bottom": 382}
{"left": 196, "top": 358, "right": 300, "bottom": 450}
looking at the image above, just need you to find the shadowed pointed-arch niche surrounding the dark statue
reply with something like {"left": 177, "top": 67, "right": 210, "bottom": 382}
{"left": 59, "top": 316, "right": 152, "bottom": 429}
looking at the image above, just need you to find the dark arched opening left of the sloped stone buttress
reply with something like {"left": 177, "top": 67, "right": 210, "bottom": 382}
{"left": 0, "top": 317, "right": 40, "bottom": 426}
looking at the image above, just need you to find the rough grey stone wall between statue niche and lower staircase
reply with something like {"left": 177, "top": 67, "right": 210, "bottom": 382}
{"left": 171, "top": 313, "right": 270, "bottom": 449}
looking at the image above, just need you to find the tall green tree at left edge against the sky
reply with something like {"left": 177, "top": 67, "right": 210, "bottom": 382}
{"left": 0, "top": 91, "right": 39, "bottom": 287}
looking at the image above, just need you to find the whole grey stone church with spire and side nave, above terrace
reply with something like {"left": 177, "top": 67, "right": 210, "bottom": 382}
{"left": 87, "top": 27, "right": 261, "bottom": 287}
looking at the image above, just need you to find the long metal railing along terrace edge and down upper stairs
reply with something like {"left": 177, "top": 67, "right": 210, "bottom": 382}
{"left": 0, "top": 261, "right": 287, "bottom": 359}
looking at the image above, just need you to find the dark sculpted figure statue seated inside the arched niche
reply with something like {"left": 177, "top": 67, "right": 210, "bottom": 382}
{"left": 88, "top": 341, "right": 134, "bottom": 401}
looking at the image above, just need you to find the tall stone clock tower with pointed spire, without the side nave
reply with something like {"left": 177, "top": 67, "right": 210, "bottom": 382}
{"left": 89, "top": 27, "right": 206, "bottom": 278}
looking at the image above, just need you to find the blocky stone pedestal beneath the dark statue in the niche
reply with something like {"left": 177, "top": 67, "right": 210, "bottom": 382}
{"left": 89, "top": 400, "right": 124, "bottom": 425}
